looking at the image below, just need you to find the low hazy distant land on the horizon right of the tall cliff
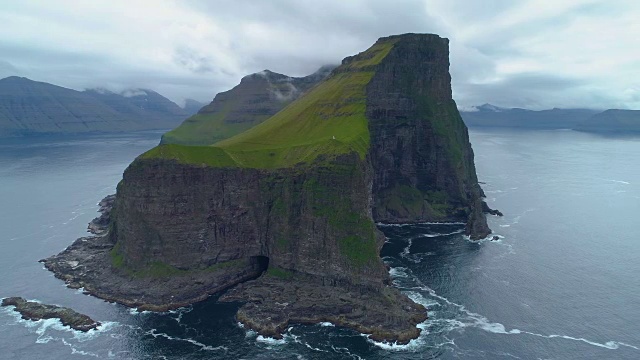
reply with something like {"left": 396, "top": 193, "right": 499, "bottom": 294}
{"left": 460, "top": 104, "right": 640, "bottom": 134}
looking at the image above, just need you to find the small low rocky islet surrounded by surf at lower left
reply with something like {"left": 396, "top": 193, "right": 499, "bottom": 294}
{"left": 2, "top": 297, "right": 100, "bottom": 332}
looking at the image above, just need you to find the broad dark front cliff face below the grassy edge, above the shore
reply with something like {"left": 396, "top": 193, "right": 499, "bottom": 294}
{"left": 111, "top": 155, "right": 386, "bottom": 286}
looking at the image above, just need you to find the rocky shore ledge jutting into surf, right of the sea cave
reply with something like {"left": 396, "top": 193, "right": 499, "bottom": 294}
{"left": 219, "top": 274, "right": 427, "bottom": 344}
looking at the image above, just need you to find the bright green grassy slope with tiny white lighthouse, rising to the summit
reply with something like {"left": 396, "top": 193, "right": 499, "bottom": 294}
{"left": 142, "top": 39, "right": 395, "bottom": 168}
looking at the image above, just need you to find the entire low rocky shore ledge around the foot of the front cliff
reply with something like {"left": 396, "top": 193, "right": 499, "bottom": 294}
{"left": 40, "top": 195, "right": 427, "bottom": 344}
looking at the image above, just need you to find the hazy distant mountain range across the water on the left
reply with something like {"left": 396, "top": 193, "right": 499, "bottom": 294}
{"left": 0, "top": 76, "right": 192, "bottom": 137}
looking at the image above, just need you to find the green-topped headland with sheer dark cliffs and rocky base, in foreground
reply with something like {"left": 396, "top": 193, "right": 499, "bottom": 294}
{"left": 44, "top": 34, "right": 490, "bottom": 343}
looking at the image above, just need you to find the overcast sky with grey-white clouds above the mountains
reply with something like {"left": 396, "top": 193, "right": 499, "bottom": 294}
{"left": 0, "top": 0, "right": 640, "bottom": 109}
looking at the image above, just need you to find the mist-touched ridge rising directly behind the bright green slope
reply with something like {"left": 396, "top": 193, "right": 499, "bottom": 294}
{"left": 161, "top": 66, "right": 334, "bottom": 145}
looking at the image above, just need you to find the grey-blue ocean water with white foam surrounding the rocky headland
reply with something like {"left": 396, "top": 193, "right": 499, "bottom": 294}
{"left": 0, "top": 130, "right": 640, "bottom": 360}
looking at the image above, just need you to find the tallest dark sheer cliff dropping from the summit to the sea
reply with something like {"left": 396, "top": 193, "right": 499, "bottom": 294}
{"left": 367, "top": 35, "right": 490, "bottom": 238}
